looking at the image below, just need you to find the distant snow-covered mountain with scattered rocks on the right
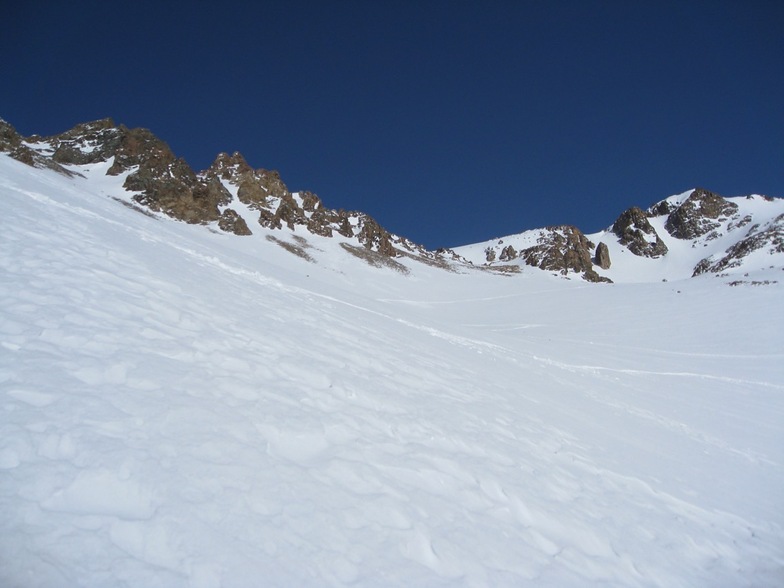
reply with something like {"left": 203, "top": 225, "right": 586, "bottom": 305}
{"left": 456, "top": 189, "right": 784, "bottom": 285}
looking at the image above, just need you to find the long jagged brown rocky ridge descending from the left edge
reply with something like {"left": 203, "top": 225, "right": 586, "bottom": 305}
{"left": 0, "top": 118, "right": 434, "bottom": 259}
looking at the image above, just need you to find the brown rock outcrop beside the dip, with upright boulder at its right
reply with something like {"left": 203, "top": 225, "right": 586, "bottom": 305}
{"left": 519, "top": 225, "right": 611, "bottom": 282}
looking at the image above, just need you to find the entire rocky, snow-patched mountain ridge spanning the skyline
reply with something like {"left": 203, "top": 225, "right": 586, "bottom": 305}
{"left": 0, "top": 118, "right": 784, "bottom": 283}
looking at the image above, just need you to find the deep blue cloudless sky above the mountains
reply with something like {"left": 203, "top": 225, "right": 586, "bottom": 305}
{"left": 0, "top": 0, "right": 784, "bottom": 247}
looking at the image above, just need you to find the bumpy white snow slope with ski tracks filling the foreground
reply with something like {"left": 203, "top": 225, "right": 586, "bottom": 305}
{"left": 0, "top": 156, "right": 784, "bottom": 588}
